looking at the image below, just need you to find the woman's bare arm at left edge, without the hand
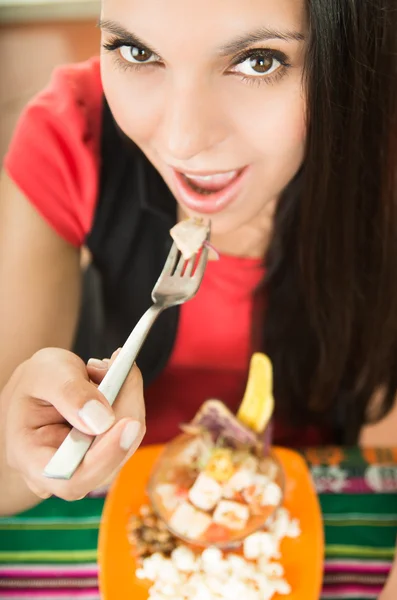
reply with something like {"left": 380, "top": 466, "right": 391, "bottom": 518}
{"left": 0, "top": 173, "right": 81, "bottom": 514}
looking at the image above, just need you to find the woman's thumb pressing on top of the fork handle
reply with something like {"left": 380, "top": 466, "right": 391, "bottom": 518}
{"left": 22, "top": 348, "right": 115, "bottom": 435}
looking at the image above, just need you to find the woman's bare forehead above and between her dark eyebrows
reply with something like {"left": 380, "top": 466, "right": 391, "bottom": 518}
{"left": 102, "top": 0, "right": 306, "bottom": 51}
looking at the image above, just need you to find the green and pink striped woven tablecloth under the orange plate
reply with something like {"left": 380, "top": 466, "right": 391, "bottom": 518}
{"left": 0, "top": 449, "right": 397, "bottom": 600}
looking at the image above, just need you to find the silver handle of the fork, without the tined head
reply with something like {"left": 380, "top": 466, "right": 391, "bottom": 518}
{"left": 44, "top": 304, "right": 164, "bottom": 480}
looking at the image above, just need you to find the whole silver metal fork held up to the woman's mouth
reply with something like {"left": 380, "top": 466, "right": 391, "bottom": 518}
{"left": 44, "top": 231, "right": 210, "bottom": 479}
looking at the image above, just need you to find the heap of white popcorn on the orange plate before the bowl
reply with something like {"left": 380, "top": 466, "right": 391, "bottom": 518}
{"left": 136, "top": 501, "right": 300, "bottom": 600}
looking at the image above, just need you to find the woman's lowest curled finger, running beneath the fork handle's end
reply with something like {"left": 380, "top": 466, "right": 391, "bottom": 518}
{"left": 27, "top": 419, "right": 145, "bottom": 500}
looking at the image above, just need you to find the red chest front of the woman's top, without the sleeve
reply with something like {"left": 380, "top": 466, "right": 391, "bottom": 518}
{"left": 146, "top": 256, "right": 264, "bottom": 441}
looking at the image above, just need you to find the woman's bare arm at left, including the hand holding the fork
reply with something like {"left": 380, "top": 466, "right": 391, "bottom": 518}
{"left": 0, "top": 170, "right": 145, "bottom": 515}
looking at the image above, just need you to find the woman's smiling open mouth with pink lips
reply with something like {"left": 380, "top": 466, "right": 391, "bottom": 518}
{"left": 172, "top": 167, "right": 248, "bottom": 214}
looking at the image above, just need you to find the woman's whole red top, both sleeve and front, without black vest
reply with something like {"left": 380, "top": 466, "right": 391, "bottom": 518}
{"left": 5, "top": 58, "right": 326, "bottom": 443}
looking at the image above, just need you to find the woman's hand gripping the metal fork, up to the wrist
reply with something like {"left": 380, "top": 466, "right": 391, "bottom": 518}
{"left": 1, "top": 348, "right": 145, "bottom": 500}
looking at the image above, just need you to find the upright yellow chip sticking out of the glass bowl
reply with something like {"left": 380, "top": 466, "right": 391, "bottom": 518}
{"left": 237, "top": 352, "right": 274, "bottom": 433}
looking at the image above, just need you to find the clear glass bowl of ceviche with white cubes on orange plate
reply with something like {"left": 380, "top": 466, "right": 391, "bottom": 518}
{"left": 147, "top": 433, "right": 285, "bottom": 550}
